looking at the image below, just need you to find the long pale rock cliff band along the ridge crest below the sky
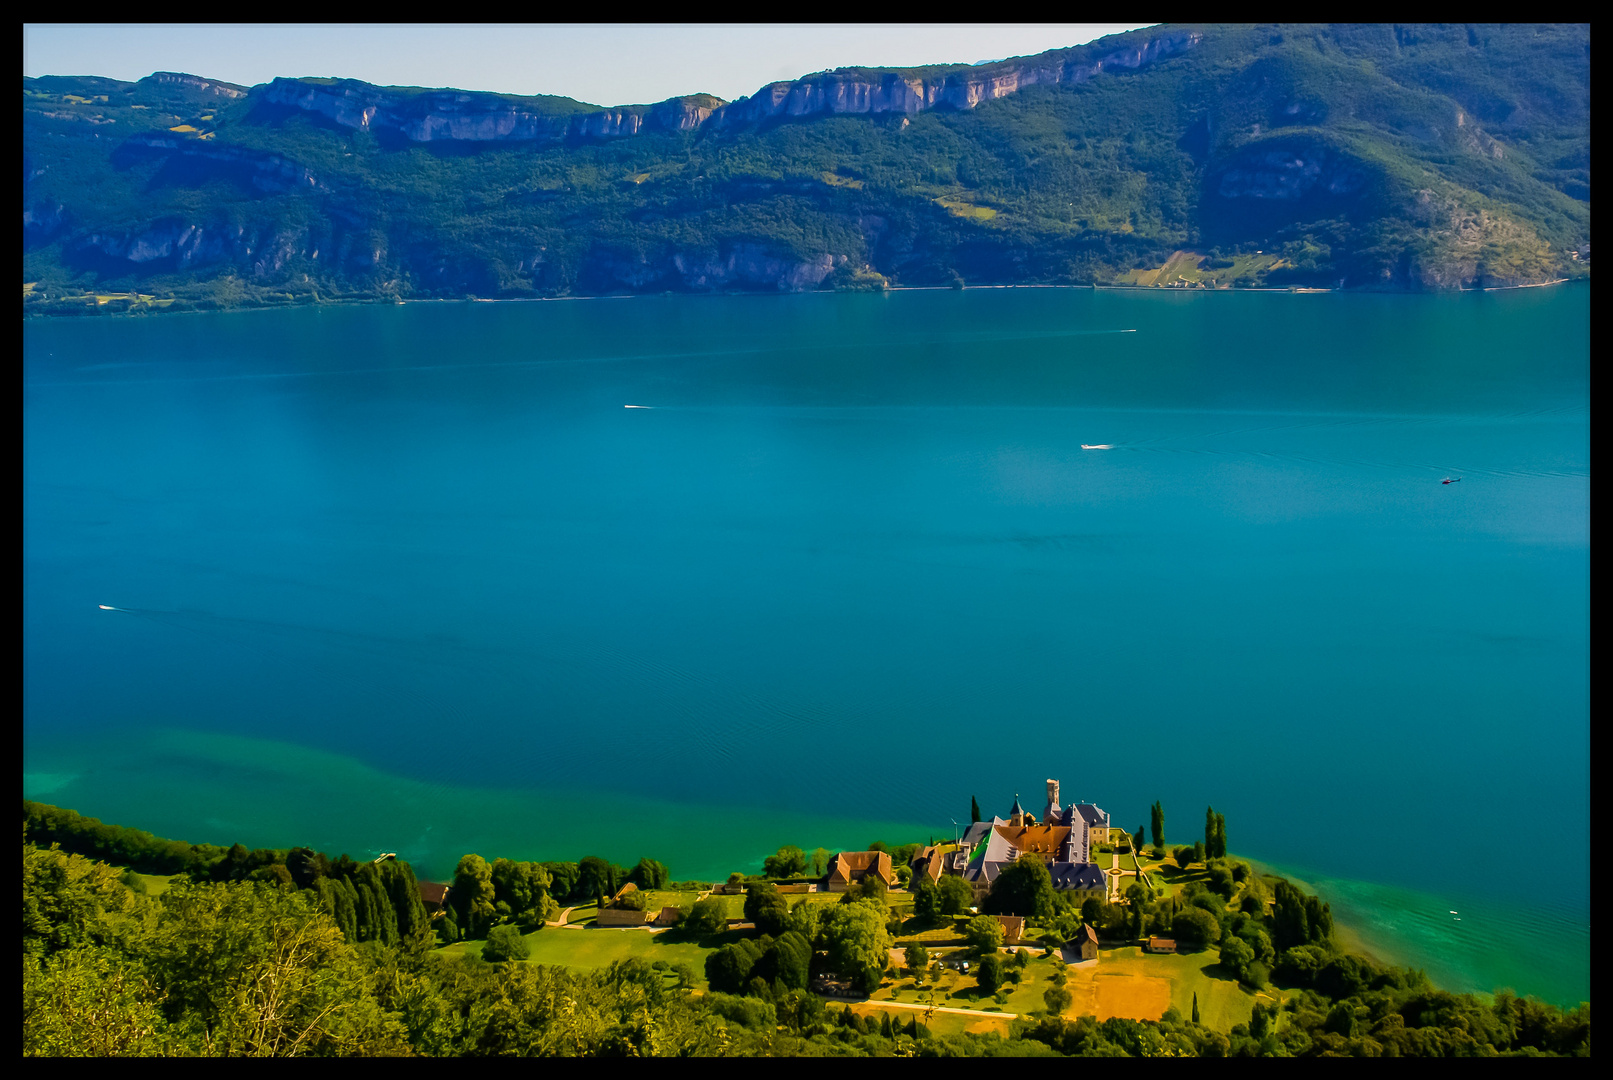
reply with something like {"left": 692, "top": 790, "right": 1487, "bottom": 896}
{"left": 263, "top": 31, "right": 1203, "bottom": 142}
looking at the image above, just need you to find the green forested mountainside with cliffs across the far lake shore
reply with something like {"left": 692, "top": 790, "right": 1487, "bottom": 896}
{"left": 23, "top": 24, "right": 1590, "bottom": 311}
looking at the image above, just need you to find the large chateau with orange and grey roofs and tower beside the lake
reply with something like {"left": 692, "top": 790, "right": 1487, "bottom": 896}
{"left": 961, "top": 780, "right": 1110, "bottom": 899}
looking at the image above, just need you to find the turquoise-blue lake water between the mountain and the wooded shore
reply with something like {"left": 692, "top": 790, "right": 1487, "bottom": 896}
{"left": 24, "top": 285, "right": 1590, "bottom": 1003}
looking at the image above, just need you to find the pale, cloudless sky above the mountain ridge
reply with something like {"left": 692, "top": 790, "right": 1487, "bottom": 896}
{"left": 23, "top": 23, "right": 1148, "bottom": 105}
